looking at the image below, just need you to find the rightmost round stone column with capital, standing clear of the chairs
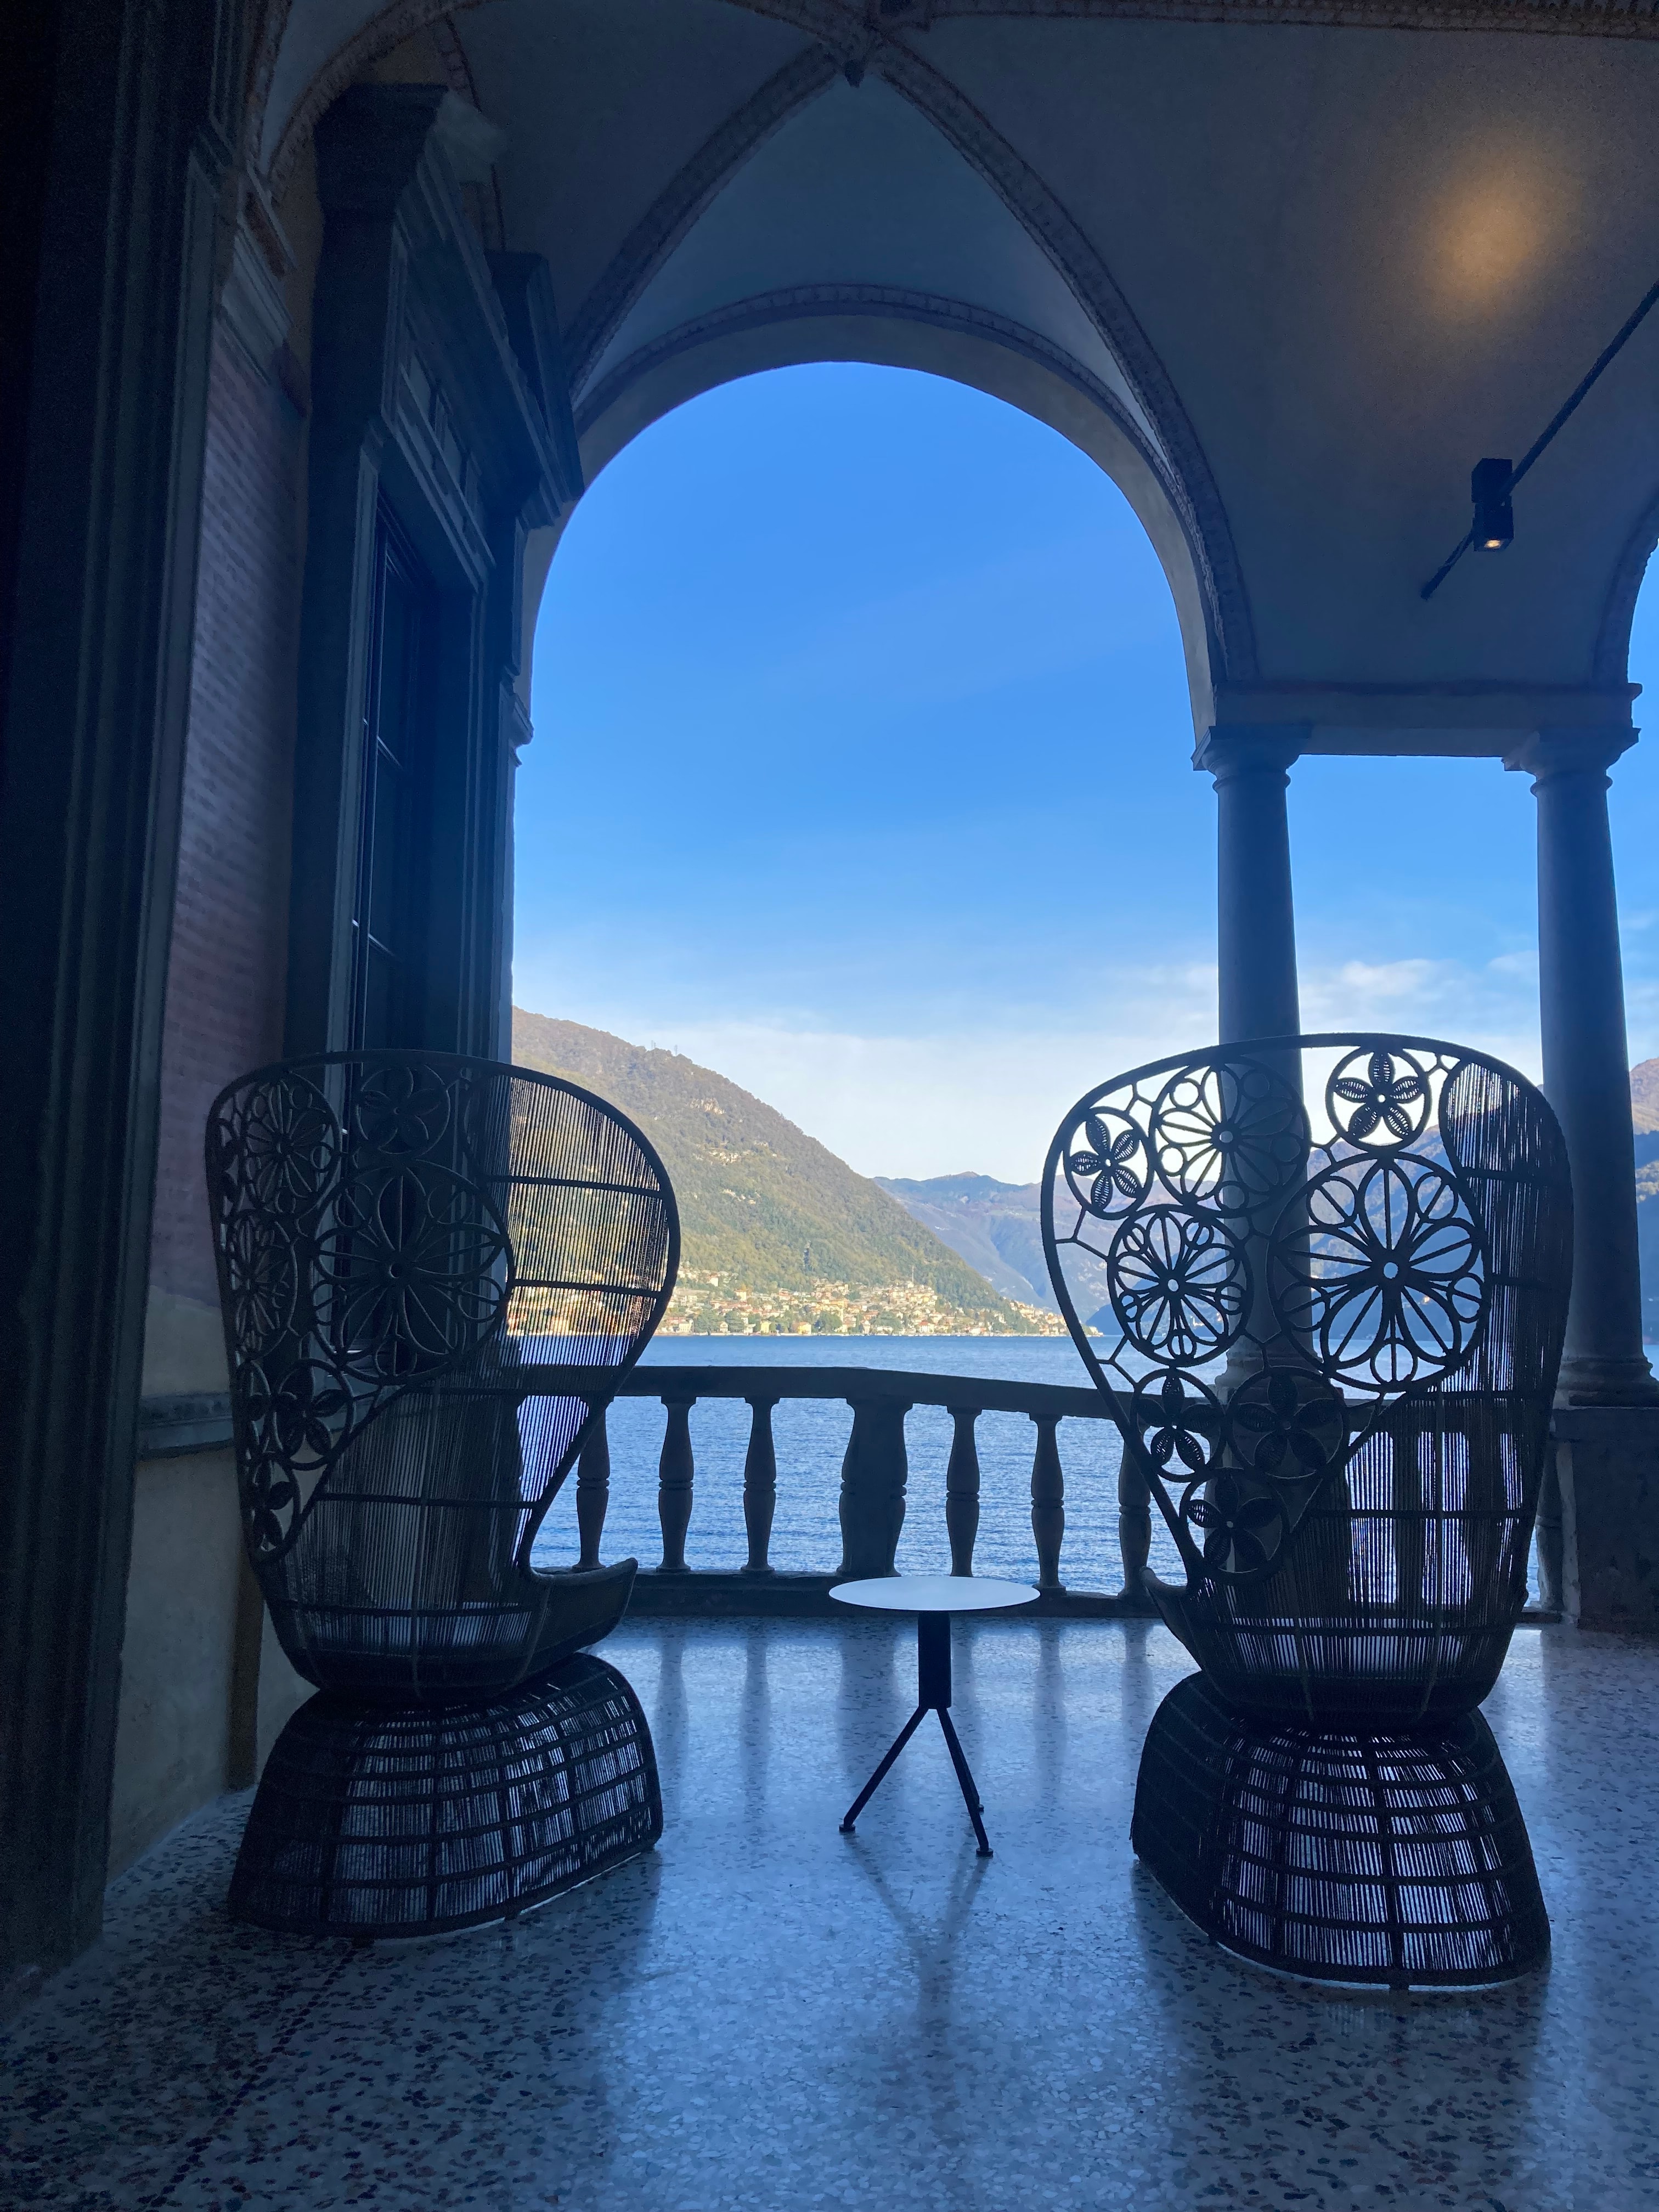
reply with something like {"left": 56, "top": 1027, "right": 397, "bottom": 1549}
{"left": 1504, "top": 728, "right": 1659, "bottom": 1404}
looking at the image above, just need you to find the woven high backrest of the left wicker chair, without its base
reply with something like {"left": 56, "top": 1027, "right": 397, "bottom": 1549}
{"left": 208, "top": 1051, "right": 679, "bottom": 1679}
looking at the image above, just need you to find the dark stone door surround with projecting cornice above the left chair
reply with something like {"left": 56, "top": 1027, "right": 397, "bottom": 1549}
{"left": 287, "top": 84, "right": 571, "bottom": 1053}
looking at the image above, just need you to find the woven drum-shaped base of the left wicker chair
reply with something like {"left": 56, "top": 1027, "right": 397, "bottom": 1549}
{"left": 228, "top": 1652, "right": 662, "bottom": 1938}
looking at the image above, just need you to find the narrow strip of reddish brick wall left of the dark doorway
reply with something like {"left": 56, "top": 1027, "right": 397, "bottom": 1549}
{"left": 146, "top": 328, "right": 303, "bottom": 1362}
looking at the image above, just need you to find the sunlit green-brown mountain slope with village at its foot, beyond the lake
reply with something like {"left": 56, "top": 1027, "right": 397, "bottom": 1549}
{"left": 513, "top": 1007, "right": 1057, "bottom": 1336}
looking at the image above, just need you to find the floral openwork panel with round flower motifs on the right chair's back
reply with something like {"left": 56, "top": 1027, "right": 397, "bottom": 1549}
{"left": 1042, "top": 1035, "right": 1566, "bottom": 1584}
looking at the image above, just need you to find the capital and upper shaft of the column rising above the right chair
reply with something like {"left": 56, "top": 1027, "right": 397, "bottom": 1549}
{"left": 1192, "top": 723, "right": 1307, "bottom": 1044}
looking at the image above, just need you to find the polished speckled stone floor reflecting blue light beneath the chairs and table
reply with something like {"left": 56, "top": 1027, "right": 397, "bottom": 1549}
{"left": 0, "top": 1621, "right": 1659, "bottom": 2212}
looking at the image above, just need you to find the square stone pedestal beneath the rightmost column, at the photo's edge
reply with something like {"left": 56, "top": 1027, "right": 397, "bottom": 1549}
{"left": 1550, "top": 1404, "right": 1659, "bottom": 1635}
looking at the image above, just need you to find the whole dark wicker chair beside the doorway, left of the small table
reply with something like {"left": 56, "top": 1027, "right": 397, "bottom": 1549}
{"left": 208, "top": 1051, "right": 679, "bottom": 1938}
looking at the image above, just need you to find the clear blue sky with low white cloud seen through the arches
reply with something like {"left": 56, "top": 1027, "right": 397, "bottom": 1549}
{"left": 515, "top": 365, "right": 1659, "bottom": 1181}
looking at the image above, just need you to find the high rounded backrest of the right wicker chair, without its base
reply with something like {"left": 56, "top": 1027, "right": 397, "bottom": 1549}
{"left": 1042, "top": 1033, "right": 1573, "bottom": 1672}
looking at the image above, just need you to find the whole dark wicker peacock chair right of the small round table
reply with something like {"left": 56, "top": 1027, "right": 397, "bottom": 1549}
{"left": 1042, "top": 1035, "right": 1573, "bottom": 1987}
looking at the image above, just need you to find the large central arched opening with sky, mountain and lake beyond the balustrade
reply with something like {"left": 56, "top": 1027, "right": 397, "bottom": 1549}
{"left": 513, "top": 360, "right": 1215, "bottom": 1584}
